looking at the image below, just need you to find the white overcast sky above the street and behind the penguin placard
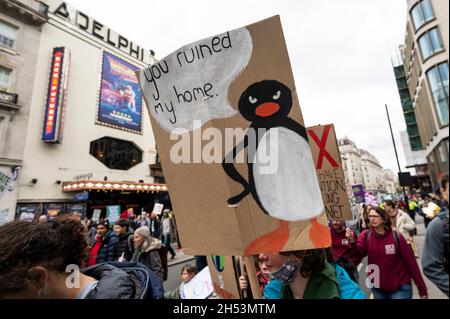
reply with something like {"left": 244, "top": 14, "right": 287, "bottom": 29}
{"left": 68, "top": 0, "right": 407, "bottom": 172}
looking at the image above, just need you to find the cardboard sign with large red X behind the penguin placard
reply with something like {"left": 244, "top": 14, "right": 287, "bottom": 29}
{"left": 307, "top": 124, "right": 353, "bottom": 220}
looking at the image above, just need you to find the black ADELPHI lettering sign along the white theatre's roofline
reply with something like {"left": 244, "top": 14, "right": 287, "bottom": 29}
{"left": 51, "top": 2, "right": 150, "bottom": 62}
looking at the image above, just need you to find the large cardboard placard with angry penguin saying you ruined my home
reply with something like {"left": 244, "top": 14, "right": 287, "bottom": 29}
{"left": 137, "top": 16, "right": 331, "bottom": 256}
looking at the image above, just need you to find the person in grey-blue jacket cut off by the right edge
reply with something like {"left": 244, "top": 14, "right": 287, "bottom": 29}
{"left": 422, "top": 176, "right": 450, "bottom": 296}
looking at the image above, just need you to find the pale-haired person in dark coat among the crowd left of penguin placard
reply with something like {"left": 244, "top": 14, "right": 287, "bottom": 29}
{"left": 131, "top": 226, "right": 167, "bottom": 281}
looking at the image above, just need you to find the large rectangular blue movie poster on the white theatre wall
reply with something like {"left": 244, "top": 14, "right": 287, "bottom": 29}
{"left": 97, "top": 52, "right": 142, "bottom": 134}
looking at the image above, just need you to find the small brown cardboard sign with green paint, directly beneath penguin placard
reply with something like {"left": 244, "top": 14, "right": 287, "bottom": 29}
{"left": 207, "top": 255, "right": 241, "bottom": 299}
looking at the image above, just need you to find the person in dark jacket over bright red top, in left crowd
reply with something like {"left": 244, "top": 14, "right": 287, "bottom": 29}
{"left": 88, "top": 219, "right": 118, "bottom": 266}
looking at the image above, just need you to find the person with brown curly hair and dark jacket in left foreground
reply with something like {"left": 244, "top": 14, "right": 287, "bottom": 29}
{"left": 0, "top": 215, "right": 163, "bottom": 299}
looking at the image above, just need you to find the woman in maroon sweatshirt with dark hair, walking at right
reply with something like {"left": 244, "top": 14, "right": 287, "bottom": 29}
{"left": 347, "top": 207, "right": 428, "bottom": 299}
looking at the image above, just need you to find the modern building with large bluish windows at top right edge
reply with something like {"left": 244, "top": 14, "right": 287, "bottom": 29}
{"left": 402, "top": 0, "right": 449, "bottom": 188}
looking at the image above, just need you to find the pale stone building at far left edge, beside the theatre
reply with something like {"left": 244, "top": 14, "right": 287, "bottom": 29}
{"left": 0, "top": 0, "right": 48, "bottom": 224}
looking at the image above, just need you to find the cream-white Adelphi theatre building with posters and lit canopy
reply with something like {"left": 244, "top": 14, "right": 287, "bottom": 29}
{"left": 11, "top": 0, "right": 170, "bottom": 219}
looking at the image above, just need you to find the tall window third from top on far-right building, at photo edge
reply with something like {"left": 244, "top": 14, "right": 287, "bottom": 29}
{"left": 427, "top": 63, "right": 448, "bottom": 126}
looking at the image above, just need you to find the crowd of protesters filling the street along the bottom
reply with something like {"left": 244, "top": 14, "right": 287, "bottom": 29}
{"left": 0, "top": 178, "right": 449, "bottom": 299}
